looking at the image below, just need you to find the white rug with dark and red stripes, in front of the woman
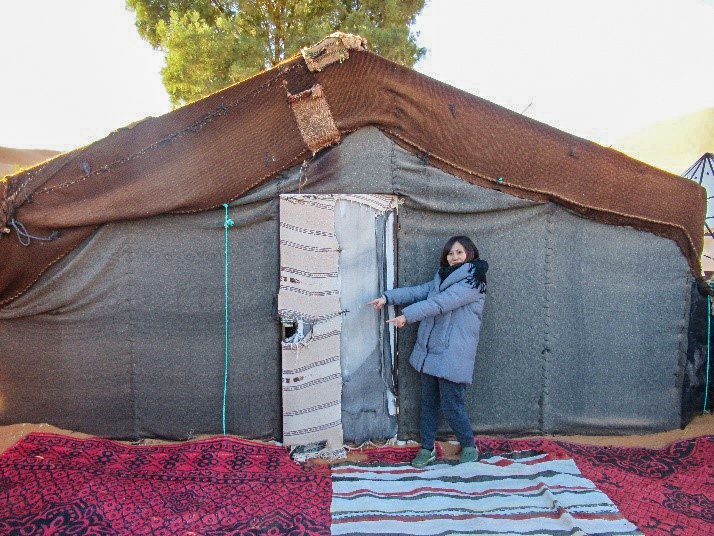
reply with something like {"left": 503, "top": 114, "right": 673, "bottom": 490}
{"left": 330, "top": 451, "right": 642, "bottom": 535}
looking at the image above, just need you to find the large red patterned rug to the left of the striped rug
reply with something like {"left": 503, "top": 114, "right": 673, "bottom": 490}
{"left": 0, "top": 434, "right": 332, "bottom": 536}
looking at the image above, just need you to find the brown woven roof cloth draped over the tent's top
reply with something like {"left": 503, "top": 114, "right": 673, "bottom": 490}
{"left": 0, "top": 35, "right": 706, "bottom": 306}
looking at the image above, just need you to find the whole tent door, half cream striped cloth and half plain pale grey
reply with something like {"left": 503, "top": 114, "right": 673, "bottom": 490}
{"left": 278, "top": 194, "right": 397, "bottom": 450}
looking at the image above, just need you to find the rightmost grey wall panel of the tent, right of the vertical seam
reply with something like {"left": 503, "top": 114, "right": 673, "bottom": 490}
{"left": 542, "top": 209, "right": 691, "bottom": 433}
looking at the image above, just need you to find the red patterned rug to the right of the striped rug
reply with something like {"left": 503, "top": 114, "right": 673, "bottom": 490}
{"left": 477, "top": 436, "right": 714, "bottom": 536}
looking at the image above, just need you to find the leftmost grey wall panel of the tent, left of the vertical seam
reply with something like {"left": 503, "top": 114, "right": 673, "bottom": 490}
{"left": 0, "top": 224, "right": 136, "bottom": 437}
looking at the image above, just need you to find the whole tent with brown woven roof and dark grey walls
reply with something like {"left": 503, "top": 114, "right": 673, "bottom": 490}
{"left": 0, "top": 34, "right": 706, "bottom": 445}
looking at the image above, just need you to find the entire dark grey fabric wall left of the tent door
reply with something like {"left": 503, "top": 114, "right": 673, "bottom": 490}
{"left": 0, "top": 201, "right": 282, "bottom": 439}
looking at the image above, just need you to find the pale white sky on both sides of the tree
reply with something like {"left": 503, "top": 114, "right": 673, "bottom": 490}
{"left": 0, "top": 0, "right": 714, "bottom": 150}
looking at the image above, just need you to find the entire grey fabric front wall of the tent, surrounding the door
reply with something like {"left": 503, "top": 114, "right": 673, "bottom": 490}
{"left": 0, "top": 127, "right": 705, "bottom": 439}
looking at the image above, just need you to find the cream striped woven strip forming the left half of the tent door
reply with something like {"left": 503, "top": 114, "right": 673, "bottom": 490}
{"left": 278, "top": 196, "right": 344, "bottom": 454}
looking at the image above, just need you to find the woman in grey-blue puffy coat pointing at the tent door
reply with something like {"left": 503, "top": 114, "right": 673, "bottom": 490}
{"left": 369, "top": 236, "right": 488, "bottom": 467}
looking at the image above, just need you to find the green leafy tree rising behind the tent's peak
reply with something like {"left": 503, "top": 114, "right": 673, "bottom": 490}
{"left": 126, "top": 0, "right": 426, "bottom": 106}
